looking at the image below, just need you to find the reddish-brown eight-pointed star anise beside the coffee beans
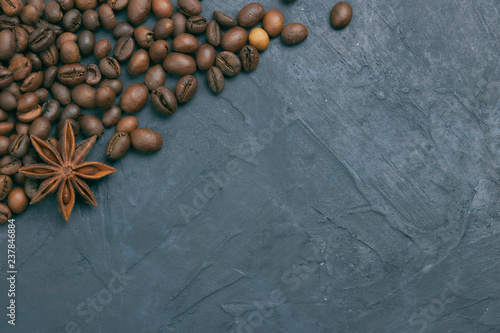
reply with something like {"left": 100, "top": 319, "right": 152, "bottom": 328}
{"left": 19, "top": 120, "right": 116, "bottom": 221}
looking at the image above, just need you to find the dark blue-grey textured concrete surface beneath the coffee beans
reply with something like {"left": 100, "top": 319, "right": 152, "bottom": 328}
{"left": 0, "top": 0, "right": 500, "bottom": 333}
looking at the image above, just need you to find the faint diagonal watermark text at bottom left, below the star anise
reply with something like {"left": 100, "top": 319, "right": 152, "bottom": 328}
{"left": 64, "top": 268, "right": 134, "bottom": 333}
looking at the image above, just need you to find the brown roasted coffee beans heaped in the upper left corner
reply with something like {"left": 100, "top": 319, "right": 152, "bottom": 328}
{"left": 0, "top": 0, "right": 352, "bottom": 223}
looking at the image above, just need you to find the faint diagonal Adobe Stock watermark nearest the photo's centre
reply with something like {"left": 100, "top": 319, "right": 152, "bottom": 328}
{"left": 178, "top": 106, "right": 295, "bottom": 224}
